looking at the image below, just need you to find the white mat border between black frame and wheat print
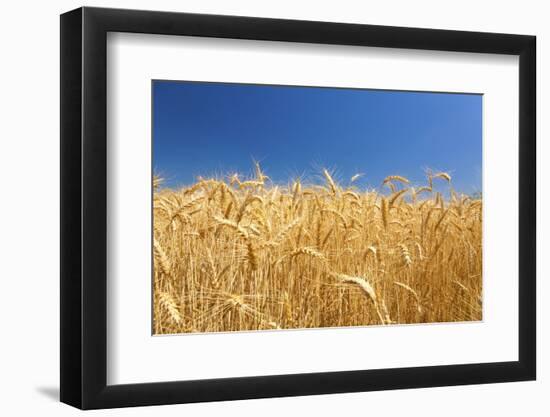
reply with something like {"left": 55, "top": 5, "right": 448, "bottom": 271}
{"left": 107, "top": 34, "right": 519, "bottom": 384}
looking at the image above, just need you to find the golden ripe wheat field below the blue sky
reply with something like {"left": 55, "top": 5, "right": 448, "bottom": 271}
{"left": 153, "top": 164, "right": 482, "bottom": 334}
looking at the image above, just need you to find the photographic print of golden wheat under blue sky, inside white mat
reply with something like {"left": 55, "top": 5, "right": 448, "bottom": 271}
{"left": 152, "top": 80, "right": 483, "bottom": 334}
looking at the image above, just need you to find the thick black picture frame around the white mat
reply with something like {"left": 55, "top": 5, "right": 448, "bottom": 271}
{"left": 60, "top": 7, "right": 536, "bottom": 409}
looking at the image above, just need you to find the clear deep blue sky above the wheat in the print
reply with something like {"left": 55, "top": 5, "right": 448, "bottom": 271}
{"left": 153, "top": 81, "right": 482, "bottom": 193}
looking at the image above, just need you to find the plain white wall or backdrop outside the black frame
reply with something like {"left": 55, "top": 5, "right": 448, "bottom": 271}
{"left": 0, "top": 0, "right": 550, "bottom": 416}
